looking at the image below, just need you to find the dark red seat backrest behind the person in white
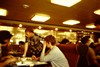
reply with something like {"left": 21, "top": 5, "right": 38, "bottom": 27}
{"left": 57, "top": 44, "right": 79, "bottom": 67}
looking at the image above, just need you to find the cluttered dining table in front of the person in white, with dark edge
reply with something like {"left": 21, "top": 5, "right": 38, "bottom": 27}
{"left": 7, "top": 57, "right": 50, "bottom": 67}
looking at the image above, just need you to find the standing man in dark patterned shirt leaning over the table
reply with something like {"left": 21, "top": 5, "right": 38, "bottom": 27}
{"left": 23, "top": 28, "right": 43, "bottom": 57}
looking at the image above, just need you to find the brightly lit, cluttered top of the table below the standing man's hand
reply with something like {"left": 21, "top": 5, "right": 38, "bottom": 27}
{"left": 10, "top": 57, "right": 48, "bottom": 67}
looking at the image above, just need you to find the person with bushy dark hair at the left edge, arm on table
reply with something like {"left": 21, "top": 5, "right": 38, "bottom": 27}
{"left": 0, "top": 30, "right": 17, "bottom": 67}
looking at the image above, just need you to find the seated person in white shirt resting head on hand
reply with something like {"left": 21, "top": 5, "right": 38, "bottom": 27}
{"left": 40, "top": 35, "right": 69, "bottom": 67}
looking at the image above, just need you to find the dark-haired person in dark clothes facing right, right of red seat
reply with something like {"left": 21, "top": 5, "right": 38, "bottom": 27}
{"left": 77, "top": 36, "right": 100, "bottom": 67}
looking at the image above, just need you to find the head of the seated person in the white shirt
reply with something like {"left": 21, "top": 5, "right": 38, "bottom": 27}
{"left": 44, "top": 35, "right": 56, "bottom": 48}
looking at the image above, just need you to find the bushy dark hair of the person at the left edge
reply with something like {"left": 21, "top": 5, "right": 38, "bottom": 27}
{"left": 0, "top": 30, "right": 12, "bottom": 44}
